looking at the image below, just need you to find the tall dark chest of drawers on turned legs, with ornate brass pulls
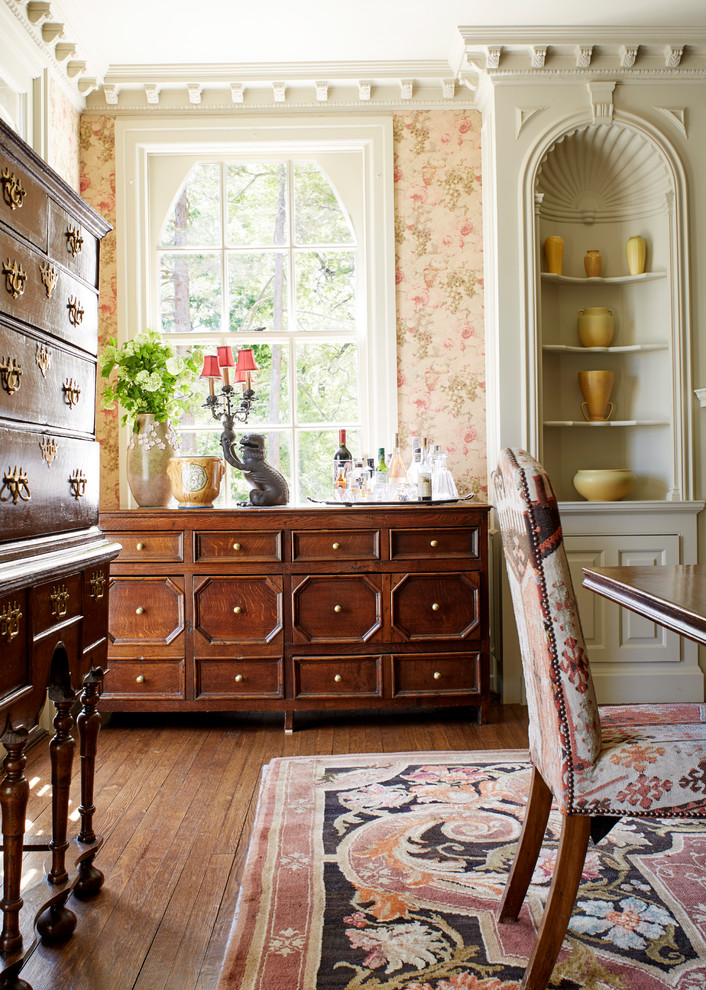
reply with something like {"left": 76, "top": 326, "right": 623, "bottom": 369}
{"left": 0, "top": 120, "right": 119, "bottom": 988}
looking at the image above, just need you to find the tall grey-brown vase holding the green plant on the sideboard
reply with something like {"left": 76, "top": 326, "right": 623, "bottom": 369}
{"left": 127, "top": 413, "right": 179, "bottom": 508}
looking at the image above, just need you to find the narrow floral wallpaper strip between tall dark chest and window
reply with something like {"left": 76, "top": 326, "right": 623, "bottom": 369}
{"left": 79, "top": 116, "right": 120, "bottom": 511}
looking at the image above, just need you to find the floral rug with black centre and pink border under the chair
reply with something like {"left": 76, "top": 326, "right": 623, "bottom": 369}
{"left": 219, "top": 751, "right": 706, "bottom": 990}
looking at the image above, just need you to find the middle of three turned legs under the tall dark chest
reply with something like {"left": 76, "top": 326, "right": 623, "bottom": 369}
{"left": 47, "top": 688, "right": 76, "bottom": 883}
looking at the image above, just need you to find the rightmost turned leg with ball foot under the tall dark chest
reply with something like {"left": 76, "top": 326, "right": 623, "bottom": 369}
{"left": 74, "top": 667, "right": 105, "bottom": 897}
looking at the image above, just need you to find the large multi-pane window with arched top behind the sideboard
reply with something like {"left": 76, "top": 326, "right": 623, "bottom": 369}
{"left": 121, "top": 116, "right": 396, "bottom": 506}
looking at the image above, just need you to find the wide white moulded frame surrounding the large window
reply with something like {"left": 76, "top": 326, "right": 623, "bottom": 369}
{"left": 115, "top": 117, "right": 397, "bottom": 505}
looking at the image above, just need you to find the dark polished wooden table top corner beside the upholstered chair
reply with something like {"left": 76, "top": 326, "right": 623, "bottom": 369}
{"left": 583, "top": 564, "right": 706, "bottom": 645}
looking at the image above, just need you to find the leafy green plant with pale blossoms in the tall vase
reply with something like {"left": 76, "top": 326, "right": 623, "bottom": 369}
{"left": 98, "top": 330, "right": 203, "bottom": 428}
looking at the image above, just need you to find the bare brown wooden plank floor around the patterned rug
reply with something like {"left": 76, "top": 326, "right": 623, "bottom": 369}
{"left": 12, "top": 705, "right": 527, "bottom": 990}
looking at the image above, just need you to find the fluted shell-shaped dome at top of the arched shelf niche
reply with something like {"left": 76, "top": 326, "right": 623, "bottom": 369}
{"left": 536, "top": 122, "right": 673, "bottom": 223}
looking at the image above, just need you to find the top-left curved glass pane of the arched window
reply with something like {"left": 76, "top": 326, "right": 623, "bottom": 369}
{"left": 160, "top": 164, "right": 221, "bottom": 247}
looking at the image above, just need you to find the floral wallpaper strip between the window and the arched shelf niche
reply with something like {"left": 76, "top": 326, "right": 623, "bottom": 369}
{"left": 393, "top": 110, "right": 487, "bottom": 495}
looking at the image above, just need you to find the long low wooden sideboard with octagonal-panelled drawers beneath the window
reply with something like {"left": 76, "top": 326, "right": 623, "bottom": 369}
{"left": 100, "top": 504, "right": 490, "bottom": 729}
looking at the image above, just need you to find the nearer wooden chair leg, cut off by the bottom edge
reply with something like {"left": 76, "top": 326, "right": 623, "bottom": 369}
{"left": 520, "top": 815, "right": 591, "bottom": 990}
